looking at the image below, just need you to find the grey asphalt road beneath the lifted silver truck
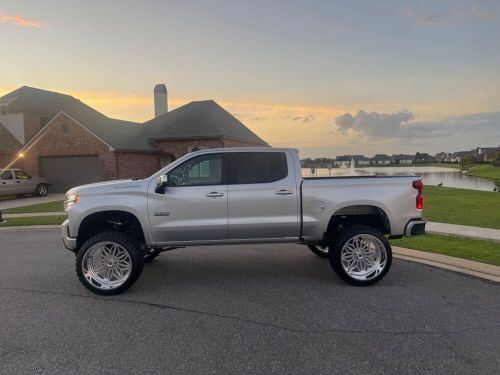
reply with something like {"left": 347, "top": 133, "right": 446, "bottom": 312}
{"left": 0, "top": 231, "right": 500, "bottom": 374}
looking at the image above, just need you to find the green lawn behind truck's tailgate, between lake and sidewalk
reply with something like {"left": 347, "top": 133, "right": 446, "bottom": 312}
{"left": 424, "top": 186, "right": 500, "bottom": 229}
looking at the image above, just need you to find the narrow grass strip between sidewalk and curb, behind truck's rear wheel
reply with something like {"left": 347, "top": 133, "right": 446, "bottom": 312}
{"left": 391, "top": 234, "right": 500, "bottom": 266}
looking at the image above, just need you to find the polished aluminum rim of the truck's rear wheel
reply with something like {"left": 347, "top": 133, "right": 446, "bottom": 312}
{"left": 340, "top": 234, "right": 387, "bottom": 280}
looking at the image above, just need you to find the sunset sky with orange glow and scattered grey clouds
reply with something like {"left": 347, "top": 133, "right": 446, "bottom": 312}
{"left": 0, "top": 0, "right": 500, "bottom": 157}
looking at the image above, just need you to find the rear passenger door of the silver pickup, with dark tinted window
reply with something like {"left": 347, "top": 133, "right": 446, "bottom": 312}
{"left": 228, "top": 151, "right": 300, "bottom": 239}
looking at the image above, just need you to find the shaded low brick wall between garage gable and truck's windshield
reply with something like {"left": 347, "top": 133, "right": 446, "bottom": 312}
{"left": 116, "top": 152, "right": 160, "bottom": 179}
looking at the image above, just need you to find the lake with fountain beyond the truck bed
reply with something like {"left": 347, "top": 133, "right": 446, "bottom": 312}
{"left": 302, "top": 166, "right": 495, "bottom": 191}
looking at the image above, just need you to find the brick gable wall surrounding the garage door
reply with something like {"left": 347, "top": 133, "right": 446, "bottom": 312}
{"left": 24, "top": 113, "right": 117, "bottom": 180}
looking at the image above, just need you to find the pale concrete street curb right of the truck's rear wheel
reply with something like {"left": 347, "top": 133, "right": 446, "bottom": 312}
{"left": 392, "top": 246, "right": 500, "bottom": 283}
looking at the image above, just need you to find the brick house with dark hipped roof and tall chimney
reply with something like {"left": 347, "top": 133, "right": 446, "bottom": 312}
{"left": 0, "top": 85, "right": 267, "bottom": 192}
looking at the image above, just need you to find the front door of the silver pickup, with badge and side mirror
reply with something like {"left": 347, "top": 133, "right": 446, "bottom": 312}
{"left": 148, "top": 153, "right": 228, "bottom": 243}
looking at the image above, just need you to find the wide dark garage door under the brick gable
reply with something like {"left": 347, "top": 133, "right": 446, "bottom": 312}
{"left": 39, "top": 156, "right": 101, "bottom": 193}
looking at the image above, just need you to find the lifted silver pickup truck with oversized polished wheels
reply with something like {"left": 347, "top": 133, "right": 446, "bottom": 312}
{"left": 62, "top": 147, "right": 426, "bottom": 295}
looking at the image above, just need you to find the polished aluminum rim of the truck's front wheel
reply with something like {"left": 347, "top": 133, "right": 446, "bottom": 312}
{"left": 82, "top": 241, "right": 132, "bottom": 289}
